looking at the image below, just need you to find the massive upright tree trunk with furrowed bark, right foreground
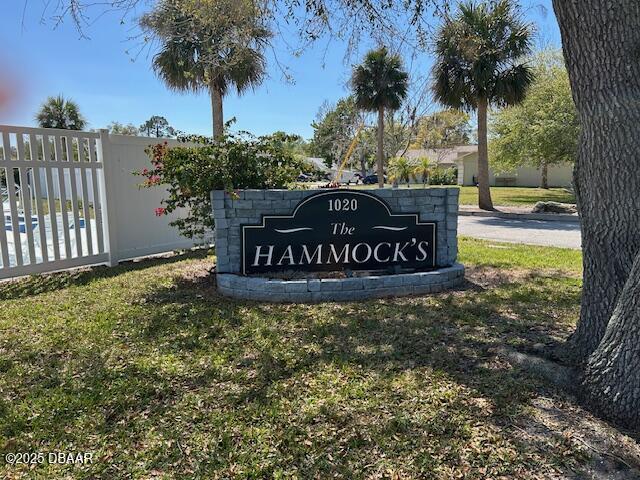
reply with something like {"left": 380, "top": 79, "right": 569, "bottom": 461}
{"left": 553, "top": 0, "right": 640, "bottom": 366}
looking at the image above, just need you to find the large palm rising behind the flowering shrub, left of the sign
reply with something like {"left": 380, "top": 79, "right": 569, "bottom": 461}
{"left": 140, "top": 0, "right": 271, "bottom": 140}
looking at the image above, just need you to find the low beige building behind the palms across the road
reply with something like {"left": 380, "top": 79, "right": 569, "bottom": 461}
{"left": 404, "top": 145, "right": 573, "bottom": 187}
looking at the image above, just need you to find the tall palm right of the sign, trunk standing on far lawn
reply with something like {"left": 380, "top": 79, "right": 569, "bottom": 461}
{"left": 433, "top": 0, "right": 533, "bottom": 210}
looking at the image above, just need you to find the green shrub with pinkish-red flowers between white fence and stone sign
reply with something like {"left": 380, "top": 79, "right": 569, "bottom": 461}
{"left": 136, "top": 133, "right": 302, "bottom": 238}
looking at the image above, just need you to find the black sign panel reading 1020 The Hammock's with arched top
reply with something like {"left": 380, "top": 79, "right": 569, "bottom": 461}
{"left": 242, "top": 190, "right": 436, "bottom": 274}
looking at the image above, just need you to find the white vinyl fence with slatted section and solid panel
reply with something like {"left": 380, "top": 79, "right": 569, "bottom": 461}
{"left": 0, "top": 125, "right": 199, "bottom": 279}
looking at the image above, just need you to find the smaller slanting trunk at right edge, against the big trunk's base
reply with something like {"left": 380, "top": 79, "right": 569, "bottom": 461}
{"left": 584, "top": 254, "right": 640, "bottom": 430}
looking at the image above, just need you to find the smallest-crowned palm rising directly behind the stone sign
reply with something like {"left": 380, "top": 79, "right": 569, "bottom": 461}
{"left": 351, "top": 47, "right": 409, "bottom": 188}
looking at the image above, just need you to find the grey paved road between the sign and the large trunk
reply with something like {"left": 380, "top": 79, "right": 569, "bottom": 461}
{"left": 458, "top": 216, "right": 580, "bottom": 248}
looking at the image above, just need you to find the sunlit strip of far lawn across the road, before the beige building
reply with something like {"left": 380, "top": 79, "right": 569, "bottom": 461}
{"left": 342, "top": 184, "right": 576, "bottom": 207}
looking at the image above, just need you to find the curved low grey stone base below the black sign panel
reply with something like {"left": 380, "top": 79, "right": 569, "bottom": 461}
{"left": 217, "top": 263, "right": 464, "bottom": 303}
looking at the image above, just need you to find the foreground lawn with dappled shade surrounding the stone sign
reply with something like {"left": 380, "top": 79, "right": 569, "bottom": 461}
{"left": 0, "top": 239, "right": 636, "bottom": 479}
